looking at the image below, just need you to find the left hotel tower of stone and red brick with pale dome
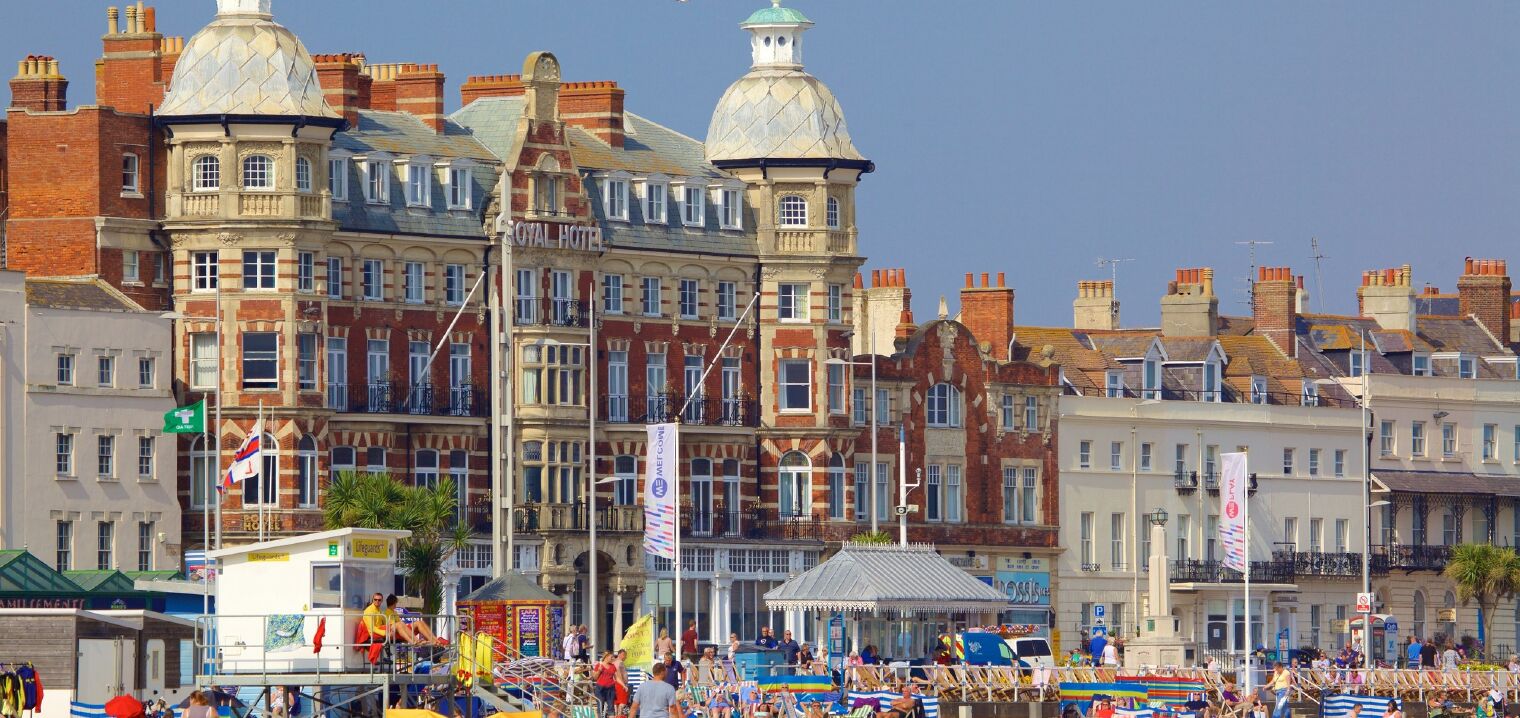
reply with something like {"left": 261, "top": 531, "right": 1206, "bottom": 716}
{"left": 157, "top": 0, "right": 344, "bottom": 542}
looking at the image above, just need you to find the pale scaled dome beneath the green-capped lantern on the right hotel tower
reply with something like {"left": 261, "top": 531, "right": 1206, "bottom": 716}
{"left": 707, "top": 67, "right": 863, "bottom": 161}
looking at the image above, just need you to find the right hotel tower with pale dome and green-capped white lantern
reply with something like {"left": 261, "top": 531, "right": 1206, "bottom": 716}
{"left": 707, "top": 0, "right": 891, "bottom": 529}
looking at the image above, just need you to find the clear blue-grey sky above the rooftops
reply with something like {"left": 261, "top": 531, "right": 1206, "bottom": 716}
{"left": 11, "top": 0, "right": 1520, "bottom": 326}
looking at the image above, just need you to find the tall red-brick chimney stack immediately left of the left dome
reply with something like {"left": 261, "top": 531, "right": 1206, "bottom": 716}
{"left": 96, "top": 2, "right": 167, "bottom": 114}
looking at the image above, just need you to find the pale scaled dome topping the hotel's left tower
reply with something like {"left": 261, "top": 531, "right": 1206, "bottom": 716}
{"left": 158, "top": 0, "right": 339, "bottom": 120}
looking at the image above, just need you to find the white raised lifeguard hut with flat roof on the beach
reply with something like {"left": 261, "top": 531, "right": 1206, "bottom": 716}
{"left": 205, "top": 528, "right": 412, "bottom": 674}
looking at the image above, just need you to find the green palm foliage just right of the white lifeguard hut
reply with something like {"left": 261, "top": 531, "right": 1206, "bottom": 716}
{"left": 322, "top": 472, "right": 470, "bottom": 613}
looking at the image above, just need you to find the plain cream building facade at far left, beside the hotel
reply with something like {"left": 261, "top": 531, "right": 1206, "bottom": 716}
{"left": 0, "top": 272, "right": 179, "bottom": 570}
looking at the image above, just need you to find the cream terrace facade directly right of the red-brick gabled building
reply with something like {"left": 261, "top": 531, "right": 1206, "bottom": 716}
{"left": 1055, "top": 397, "right": 1363, "bottom": 662}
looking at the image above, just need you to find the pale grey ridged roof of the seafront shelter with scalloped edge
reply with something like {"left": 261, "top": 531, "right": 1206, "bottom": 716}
{"left": 765, "top": 543, "right": 1012, "bottom": 613}
